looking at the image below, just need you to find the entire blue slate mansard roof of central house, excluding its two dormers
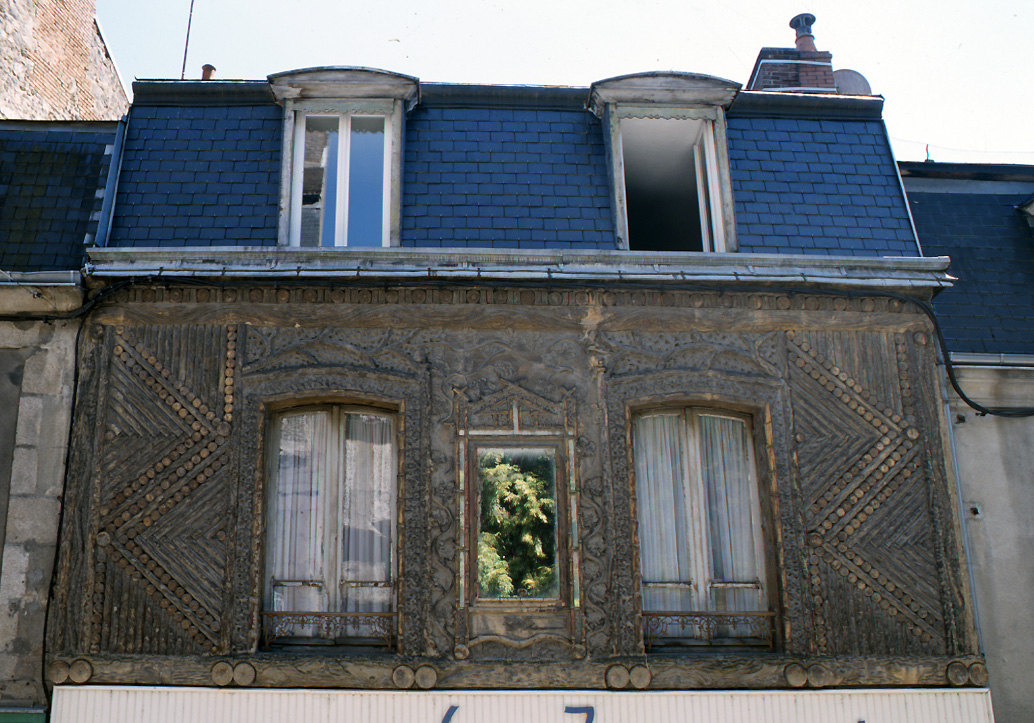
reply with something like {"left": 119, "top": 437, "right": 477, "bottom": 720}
{"left": 95, "top": 76, "right": 919, "bottom": 257}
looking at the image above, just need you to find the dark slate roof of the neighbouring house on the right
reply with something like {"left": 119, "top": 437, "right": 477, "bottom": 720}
{"left": 901, "top": 162, "right": 1034, "bottom": 355}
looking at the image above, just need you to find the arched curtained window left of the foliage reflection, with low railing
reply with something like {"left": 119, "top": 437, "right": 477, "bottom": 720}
{"left": 263, "top": 405, "right": 398, "bottom": 646}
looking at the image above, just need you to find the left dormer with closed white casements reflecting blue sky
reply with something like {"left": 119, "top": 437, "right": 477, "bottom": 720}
{"left": 269, "top": 68, "right": 417, "bottom": 247}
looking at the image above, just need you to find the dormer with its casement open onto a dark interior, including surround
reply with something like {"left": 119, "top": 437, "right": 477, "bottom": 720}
{"left": 589, "top": 72, "right": 739, "bottom": 251}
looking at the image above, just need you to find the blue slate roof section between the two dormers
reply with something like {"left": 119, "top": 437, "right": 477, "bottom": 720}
{"left": 401, "top": 108, "right": 616, "bottom": 248}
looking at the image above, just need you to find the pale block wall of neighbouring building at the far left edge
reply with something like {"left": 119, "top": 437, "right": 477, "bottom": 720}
{"left": 0, "top": 322, "right": 78, "bottom": 709}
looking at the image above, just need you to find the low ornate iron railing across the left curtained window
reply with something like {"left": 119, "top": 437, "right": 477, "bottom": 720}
{"left": 262, "top": 611, "right": 398, "bottom": 650}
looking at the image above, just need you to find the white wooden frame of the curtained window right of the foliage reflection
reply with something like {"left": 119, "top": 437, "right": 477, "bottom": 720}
{"left": 632, "top": 406, "right": 771, "bottom": 637}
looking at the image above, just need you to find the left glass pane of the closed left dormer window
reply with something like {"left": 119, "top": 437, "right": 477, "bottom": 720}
{"left": 301, "top": 116, "right": 339, "bottom": 246}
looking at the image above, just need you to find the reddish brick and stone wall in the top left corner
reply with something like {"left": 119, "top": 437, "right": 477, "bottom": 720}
{"left": 0, "top": 0, "right": 128, "bottom": 120}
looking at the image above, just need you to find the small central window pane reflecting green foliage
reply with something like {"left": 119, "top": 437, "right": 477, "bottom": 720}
{"left": 478, "top": 448, "right": 559, "bottom": 599}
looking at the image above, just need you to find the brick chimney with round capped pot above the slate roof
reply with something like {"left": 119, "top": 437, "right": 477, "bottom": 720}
{"left": 747, "top": 12, "right": 837, "bottom": 93}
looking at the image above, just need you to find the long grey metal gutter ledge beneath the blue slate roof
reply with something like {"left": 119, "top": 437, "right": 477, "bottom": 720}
{"left": 84, "top": 247, "right": 952, "bottom": 299}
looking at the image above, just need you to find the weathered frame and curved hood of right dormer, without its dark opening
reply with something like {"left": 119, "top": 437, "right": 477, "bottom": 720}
{"left": 588, "top": 72, "right": 740, "bottom": 253}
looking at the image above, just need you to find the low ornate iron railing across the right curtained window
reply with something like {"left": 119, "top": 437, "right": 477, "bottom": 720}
{"left": 643, "top": 611, "right": 776, "bottom": 651}
